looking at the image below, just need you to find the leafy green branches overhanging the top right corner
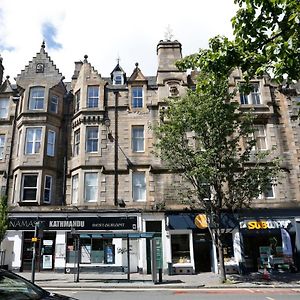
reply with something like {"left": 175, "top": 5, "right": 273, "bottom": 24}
{"left": 232, "top": 0, "right": 300, "bottom": 82}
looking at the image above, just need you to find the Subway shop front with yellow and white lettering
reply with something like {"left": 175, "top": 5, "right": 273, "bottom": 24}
{"left": 240, "top": 217, "right": 296, "bottom": 271}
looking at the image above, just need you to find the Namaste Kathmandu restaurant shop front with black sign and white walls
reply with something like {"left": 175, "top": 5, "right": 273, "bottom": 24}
{"left": 7, "top": 214, "right": 143, "bottom": 272}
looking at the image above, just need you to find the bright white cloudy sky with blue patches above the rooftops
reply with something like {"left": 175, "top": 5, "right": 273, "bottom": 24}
{"left": 0, "top": 0, "right": 236, "bottom": 81}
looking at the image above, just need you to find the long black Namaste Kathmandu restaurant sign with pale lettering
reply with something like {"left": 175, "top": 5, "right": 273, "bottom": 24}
{"left": 8, "top": 217, "right": 137, "bottom": 231}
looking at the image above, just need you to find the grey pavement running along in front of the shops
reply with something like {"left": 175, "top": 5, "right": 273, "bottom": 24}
{"left": 18, "top": 271, "right": 300, "bottom": 290}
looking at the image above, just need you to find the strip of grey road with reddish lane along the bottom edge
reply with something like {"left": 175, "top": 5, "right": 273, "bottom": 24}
{"left": 53, "top": 288, "right": 300, "bottom": 300}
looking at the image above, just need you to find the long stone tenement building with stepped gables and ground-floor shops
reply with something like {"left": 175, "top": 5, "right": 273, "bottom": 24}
{"left": 0, "top": 40, "right": 300, "bottom": 274}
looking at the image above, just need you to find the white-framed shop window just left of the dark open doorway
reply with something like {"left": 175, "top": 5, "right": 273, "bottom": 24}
{"left": 171, "top": 234, "right": 191, "bottom": 264}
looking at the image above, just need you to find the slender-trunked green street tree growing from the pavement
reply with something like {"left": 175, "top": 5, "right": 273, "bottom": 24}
{"left": 153, "top": 62, "right": 279, "bottom": 282}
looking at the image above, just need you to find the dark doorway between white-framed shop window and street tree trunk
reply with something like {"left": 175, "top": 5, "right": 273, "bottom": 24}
{"left": 194, "top": 233, "right": 212, "bottom": 273}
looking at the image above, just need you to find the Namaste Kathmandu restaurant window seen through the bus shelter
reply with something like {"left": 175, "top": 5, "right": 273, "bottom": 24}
{"left": 67, "top": 234, "right": 115, "bottom": 264}
